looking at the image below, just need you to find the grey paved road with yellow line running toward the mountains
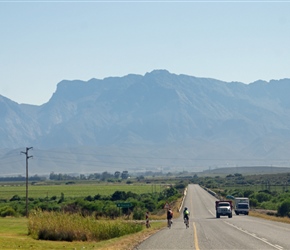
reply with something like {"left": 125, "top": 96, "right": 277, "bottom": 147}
{"left": 135, "top": 185, "right": 290, "bottom": 250}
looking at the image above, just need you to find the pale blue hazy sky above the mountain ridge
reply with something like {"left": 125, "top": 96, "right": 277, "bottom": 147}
{"left": 0, "top": 0, "right": 290, "bottom": 105}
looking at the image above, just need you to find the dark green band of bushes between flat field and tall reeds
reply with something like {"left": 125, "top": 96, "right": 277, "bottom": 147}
{"left": 0, "top": 185, "right": 184, "bottom": 220}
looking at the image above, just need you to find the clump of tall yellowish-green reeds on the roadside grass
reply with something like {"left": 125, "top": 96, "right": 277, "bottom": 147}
{"left": 28, "top": 210, "right": 143, "bottom": 241}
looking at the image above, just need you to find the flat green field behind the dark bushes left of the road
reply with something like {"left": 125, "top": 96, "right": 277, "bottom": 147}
{"left": 0, "top": 183, "right": 164, "bottom": 199}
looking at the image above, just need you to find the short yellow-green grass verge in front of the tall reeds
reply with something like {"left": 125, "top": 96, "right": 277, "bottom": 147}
{"left": 0, "top": 217, "right": 166, "bottom": 250}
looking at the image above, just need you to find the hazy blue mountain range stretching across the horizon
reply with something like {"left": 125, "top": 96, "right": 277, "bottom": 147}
{"left": 0, "top": 70, "right": 290, "bottom": 175}
